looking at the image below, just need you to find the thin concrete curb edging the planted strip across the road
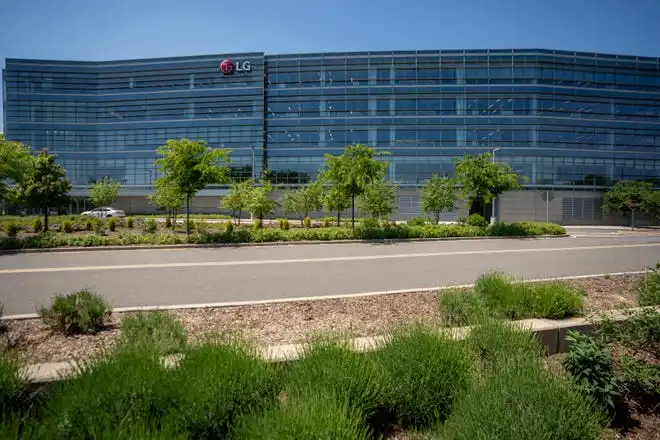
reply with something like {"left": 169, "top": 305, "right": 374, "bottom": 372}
{"left": 0, "top": 234, "right": 572, "bottom": 255}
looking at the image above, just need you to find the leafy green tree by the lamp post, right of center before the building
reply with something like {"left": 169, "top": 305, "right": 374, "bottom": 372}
{"left": 454, "top": 153, "right": 520, "bottom": 217}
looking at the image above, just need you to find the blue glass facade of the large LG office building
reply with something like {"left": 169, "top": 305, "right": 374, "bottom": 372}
{"left": 3, "top": 49, "right": 660, "bottom": 191}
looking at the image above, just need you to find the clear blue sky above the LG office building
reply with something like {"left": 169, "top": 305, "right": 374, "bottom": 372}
{"left": 0, "top": 0, "right": 660, "bottom": 131}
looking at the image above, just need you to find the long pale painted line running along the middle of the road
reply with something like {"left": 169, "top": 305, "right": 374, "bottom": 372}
{"left": 0, "top": 243, "right": 660, "bottom": 275}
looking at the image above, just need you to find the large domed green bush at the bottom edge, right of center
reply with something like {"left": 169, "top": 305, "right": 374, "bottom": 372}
{"left": 436, "top": 362, "right": 605, "bottom": 440}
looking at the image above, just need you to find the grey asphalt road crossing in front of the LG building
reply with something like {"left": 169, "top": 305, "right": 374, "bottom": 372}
{"left": 0, "top": 233, "right": 660, "bottom": 314}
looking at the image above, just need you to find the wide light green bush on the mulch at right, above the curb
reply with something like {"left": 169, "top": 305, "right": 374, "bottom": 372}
{"left": 474, "top": 272, "right": 584, "bottom": 320}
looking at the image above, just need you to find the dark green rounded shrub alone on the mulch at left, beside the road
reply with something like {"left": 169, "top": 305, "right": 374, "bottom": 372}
{"left": 39, "top": 289, "right": 111, "bottom": 334}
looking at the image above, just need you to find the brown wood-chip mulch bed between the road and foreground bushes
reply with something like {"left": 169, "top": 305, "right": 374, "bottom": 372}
{"left": 2, "top": 274, "right": 641, "bottom": 362}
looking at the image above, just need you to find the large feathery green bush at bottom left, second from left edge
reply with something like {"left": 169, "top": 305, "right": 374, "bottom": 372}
{"left": 44, "top": 344, "right": 173, "bottom": 439}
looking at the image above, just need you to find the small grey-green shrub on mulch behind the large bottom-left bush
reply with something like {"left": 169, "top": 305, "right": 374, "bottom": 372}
{"left": 121, "top": 312, "right": 187, "bottom": 354}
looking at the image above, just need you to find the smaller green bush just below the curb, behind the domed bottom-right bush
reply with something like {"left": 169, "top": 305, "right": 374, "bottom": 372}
{"left": 466, "top": 318, "right": 545, "bottom": 373}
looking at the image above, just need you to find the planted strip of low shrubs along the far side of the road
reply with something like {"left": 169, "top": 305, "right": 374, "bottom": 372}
{"left": 0, "top": 216, "right": 566, "bottom": 250}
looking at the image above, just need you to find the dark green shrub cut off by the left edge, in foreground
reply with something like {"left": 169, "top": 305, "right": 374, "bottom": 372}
{"left": 0, "top": 347, "right": 28, "bottom": 416}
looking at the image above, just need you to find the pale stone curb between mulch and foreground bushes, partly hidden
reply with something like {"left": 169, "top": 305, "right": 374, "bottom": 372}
{"left": 24, "top": 306, "right": 660, "bottom": 384}
